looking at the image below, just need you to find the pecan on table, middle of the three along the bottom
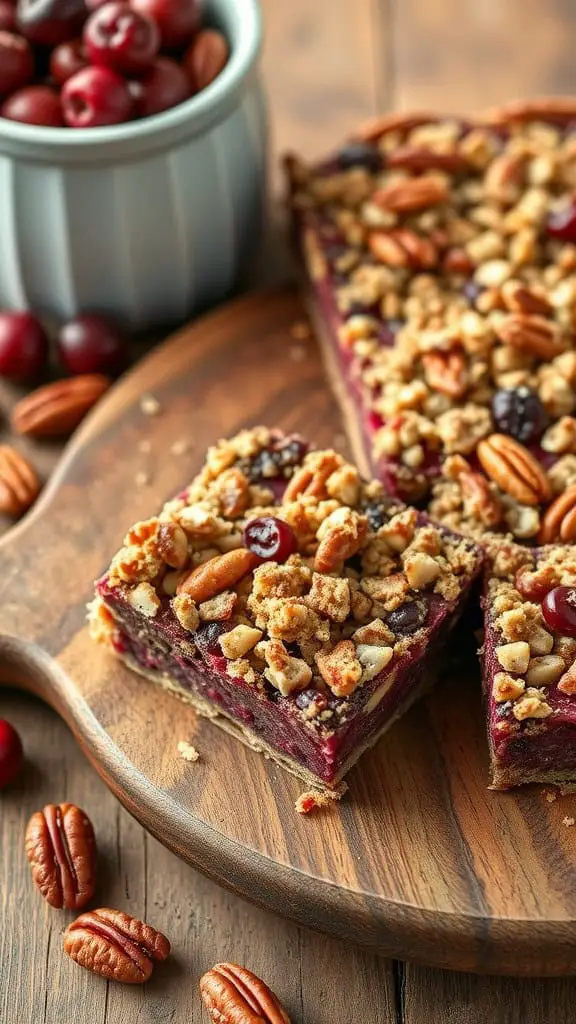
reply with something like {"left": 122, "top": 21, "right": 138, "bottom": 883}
{"left": 64, "top": 907, "right": 170, "bottom": 985}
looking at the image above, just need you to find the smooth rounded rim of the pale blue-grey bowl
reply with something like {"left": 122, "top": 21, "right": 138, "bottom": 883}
{"left": 0, "top": 0, "right": 262, "bottom": 153}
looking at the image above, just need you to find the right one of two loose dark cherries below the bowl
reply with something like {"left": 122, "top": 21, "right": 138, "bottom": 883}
{"left": 57, "top": 313, "right": 127, "bottom": 374}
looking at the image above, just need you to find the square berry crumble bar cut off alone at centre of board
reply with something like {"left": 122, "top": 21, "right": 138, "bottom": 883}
{"left": 90, "top": 427, "right": 483, "bottom": 788}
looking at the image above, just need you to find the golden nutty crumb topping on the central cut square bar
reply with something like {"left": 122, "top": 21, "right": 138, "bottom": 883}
{"left": 97, "top": 427, "right": 482, "bottom": 721}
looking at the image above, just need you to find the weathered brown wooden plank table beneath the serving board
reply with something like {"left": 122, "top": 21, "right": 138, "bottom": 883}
{"left": 0, "top": 0, "right": 576, "bottom": 1024}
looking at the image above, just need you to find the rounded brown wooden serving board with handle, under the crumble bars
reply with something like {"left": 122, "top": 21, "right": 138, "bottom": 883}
{"left": 0, "top": 292, "right": 576, "bottom": 975}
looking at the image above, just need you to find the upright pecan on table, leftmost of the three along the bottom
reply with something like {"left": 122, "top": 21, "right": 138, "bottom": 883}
{"left": 26, "top": 804, "right": 96, "bottom": 910}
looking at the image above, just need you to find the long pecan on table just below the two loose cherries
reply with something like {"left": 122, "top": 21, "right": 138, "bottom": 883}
{"left": 11, "top": 374, "right": 110, "bottom": 437}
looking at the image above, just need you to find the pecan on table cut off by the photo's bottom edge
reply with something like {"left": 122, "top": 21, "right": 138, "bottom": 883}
{"left": 200, "top": 964, "right": 290, "bottom": 1024}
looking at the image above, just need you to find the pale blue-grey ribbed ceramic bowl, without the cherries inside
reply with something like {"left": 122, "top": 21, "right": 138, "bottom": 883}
{"left": 0, "top": 0, "right": 268, "bottom": 328}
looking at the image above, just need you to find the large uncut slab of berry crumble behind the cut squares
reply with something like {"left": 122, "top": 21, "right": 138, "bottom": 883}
{"left": 286, "top": 98, "right": 576, "bottom": 544}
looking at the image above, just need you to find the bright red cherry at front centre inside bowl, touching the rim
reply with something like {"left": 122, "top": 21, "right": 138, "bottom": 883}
{"left": 61, "top": 67, "right": 132, "bottom": 128}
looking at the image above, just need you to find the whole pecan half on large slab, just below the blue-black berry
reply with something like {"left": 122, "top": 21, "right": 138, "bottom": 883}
{"left": 477, "top": 434, "right": 551, "bottom": 505}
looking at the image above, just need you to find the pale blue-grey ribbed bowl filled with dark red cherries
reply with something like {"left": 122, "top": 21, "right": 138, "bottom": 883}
{"left": 0, "top": 0, "right": 266, "bottom": 329}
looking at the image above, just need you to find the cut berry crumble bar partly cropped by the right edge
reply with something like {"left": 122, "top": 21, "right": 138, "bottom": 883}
{"left": 483, "top": 544, "right": 576, "bottom": 790}
